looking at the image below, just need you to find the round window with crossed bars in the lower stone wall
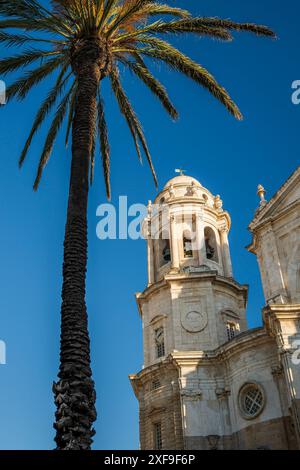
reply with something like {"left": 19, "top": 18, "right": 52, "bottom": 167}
{"left": 239, "top": 383, "right": 265, "bottom": 419}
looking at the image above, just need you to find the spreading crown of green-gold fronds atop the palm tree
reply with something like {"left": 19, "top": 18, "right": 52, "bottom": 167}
{"left": 0, "top": 0, "right": 275, "bottom": 197}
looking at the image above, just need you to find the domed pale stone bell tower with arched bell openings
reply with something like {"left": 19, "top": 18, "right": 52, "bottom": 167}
{"left": 130, "top": 175, "right": 248, "bottom": 449}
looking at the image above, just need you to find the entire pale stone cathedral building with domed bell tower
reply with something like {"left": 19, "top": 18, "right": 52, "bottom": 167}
{"left": 130, "top": 167, "right": 300, "bottom": 450}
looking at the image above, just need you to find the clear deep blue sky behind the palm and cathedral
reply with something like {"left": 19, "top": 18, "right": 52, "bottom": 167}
{"left": 0, "top": 0, "right": 300, "bottom": 449}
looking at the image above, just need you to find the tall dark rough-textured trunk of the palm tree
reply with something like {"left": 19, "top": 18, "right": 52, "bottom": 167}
{"left": 53, "top": 48, "right": 100, "bottom": 450}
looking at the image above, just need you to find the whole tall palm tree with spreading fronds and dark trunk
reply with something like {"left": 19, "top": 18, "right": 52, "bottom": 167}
{"left": 0, "top": 0, "right": 274, "bottom": 450}
